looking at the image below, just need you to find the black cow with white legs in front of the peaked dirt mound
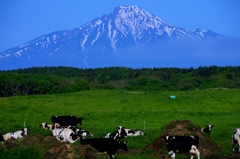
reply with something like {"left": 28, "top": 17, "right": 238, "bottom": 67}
{"left": 162, "top": 136, "right": 200, "bottom": 159}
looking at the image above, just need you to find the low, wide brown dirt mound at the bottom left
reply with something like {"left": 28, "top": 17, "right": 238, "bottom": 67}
{"left": 2, "top": 135, "right": 105, "bottom": 159}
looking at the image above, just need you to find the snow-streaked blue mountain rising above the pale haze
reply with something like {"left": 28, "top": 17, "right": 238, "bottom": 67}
{"left": 0, "top": 6, "right": 220, "bottom": 67}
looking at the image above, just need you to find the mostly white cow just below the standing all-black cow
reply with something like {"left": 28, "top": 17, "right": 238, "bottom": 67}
{"left": 53, "top": 128, "right": 80, "bottom": 143}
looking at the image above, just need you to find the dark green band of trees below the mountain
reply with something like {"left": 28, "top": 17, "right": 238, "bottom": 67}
{"left": 0, "top": 66, "right": 240, "bottom": 97}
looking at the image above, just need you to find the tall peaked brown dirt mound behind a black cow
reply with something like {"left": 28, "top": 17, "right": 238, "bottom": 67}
{"left": 142, "top": 120, "right": 223, "bottom": 158}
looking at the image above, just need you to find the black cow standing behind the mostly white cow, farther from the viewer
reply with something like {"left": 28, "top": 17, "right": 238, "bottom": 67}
{"left": 51, "top": 115, "right": 84, "bottom": 129}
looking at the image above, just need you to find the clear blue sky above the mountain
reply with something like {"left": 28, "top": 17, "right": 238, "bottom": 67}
{"left": 0, "top": 0, "right": 240, "bottom": 52}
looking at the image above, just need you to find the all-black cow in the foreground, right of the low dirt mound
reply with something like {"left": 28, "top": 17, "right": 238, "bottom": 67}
{"left": 80, "top": 138, "right": 128, "bottom": 159}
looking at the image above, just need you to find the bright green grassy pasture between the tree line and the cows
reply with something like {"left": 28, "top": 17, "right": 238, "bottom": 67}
{"left": 0, "top": 90, "right": 240, "bottom": 158}
